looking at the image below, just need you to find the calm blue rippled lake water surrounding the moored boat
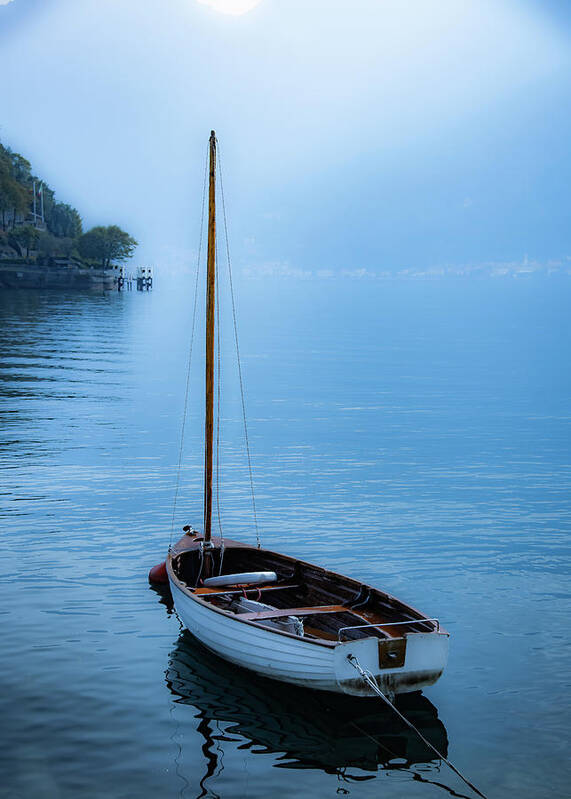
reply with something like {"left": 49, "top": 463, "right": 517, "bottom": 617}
{"left": 0, "top": 275, "right": 571, "bottom": 799}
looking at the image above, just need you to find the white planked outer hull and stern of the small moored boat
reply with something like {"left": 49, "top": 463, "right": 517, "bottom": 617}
{"left": 169, "top": 575, "right": 448, "bottom": 696}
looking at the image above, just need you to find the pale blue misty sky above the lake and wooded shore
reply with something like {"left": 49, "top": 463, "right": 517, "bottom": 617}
{"left": 0, "top": 0, "right": 571, "bottom": 271}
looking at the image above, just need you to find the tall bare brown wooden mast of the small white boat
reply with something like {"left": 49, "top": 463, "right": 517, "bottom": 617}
{"left": 204, "top": 131, "right": 216, "bottom": 548}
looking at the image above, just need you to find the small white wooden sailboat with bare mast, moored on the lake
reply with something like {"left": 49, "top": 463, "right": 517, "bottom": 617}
{"left": 151, "top": 131, "right": 449, "bottom": 696}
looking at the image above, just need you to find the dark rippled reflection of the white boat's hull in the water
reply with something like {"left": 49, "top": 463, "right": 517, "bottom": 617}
{"left": 166, "top": 631, "right": 458, "bottom": 796}
